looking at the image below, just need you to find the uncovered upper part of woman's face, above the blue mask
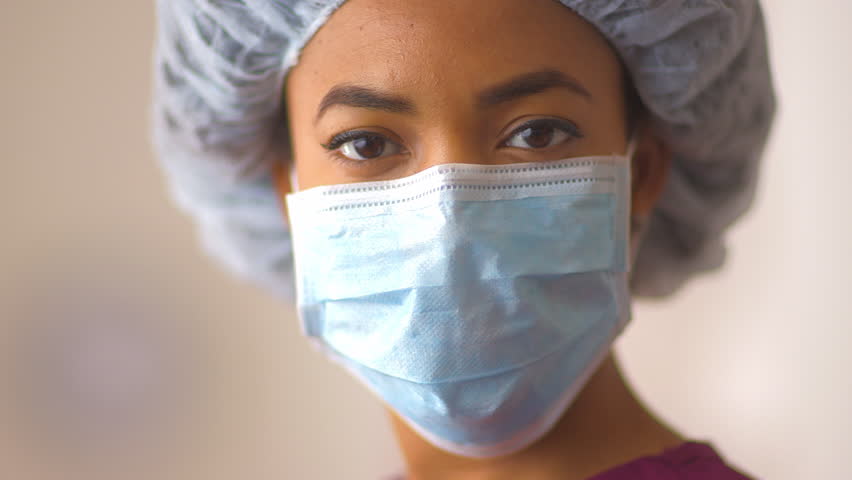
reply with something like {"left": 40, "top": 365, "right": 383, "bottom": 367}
{"left": 279, "top": 0, "right": 660, "bottom": 212}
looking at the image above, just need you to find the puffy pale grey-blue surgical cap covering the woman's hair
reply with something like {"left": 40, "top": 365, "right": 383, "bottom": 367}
{"left": 151, "top": 0, "right": 775, "bottom": 298}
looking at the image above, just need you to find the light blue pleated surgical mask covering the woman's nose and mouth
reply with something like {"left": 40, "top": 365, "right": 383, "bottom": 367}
{"left": 287, "top": 147, "right": 630, "bottom": 457}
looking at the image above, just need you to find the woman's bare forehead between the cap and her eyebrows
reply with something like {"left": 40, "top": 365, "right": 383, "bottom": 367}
{"left": 290, "top": 0, "right": 620, "bottom": 102}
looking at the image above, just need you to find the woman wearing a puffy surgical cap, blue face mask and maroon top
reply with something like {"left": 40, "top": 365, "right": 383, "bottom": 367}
{"left": 154, "top": 0, "right": 774, "bottom": 480}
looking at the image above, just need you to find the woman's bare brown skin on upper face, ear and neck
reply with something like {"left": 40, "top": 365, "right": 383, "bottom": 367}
{"left": 276, "top": 0, "right": 683, "bottom": 480}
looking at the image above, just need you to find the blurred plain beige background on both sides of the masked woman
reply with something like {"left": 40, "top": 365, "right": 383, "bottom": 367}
{"left": 0, "top": 0, "right": 852, "bottom": 480}
